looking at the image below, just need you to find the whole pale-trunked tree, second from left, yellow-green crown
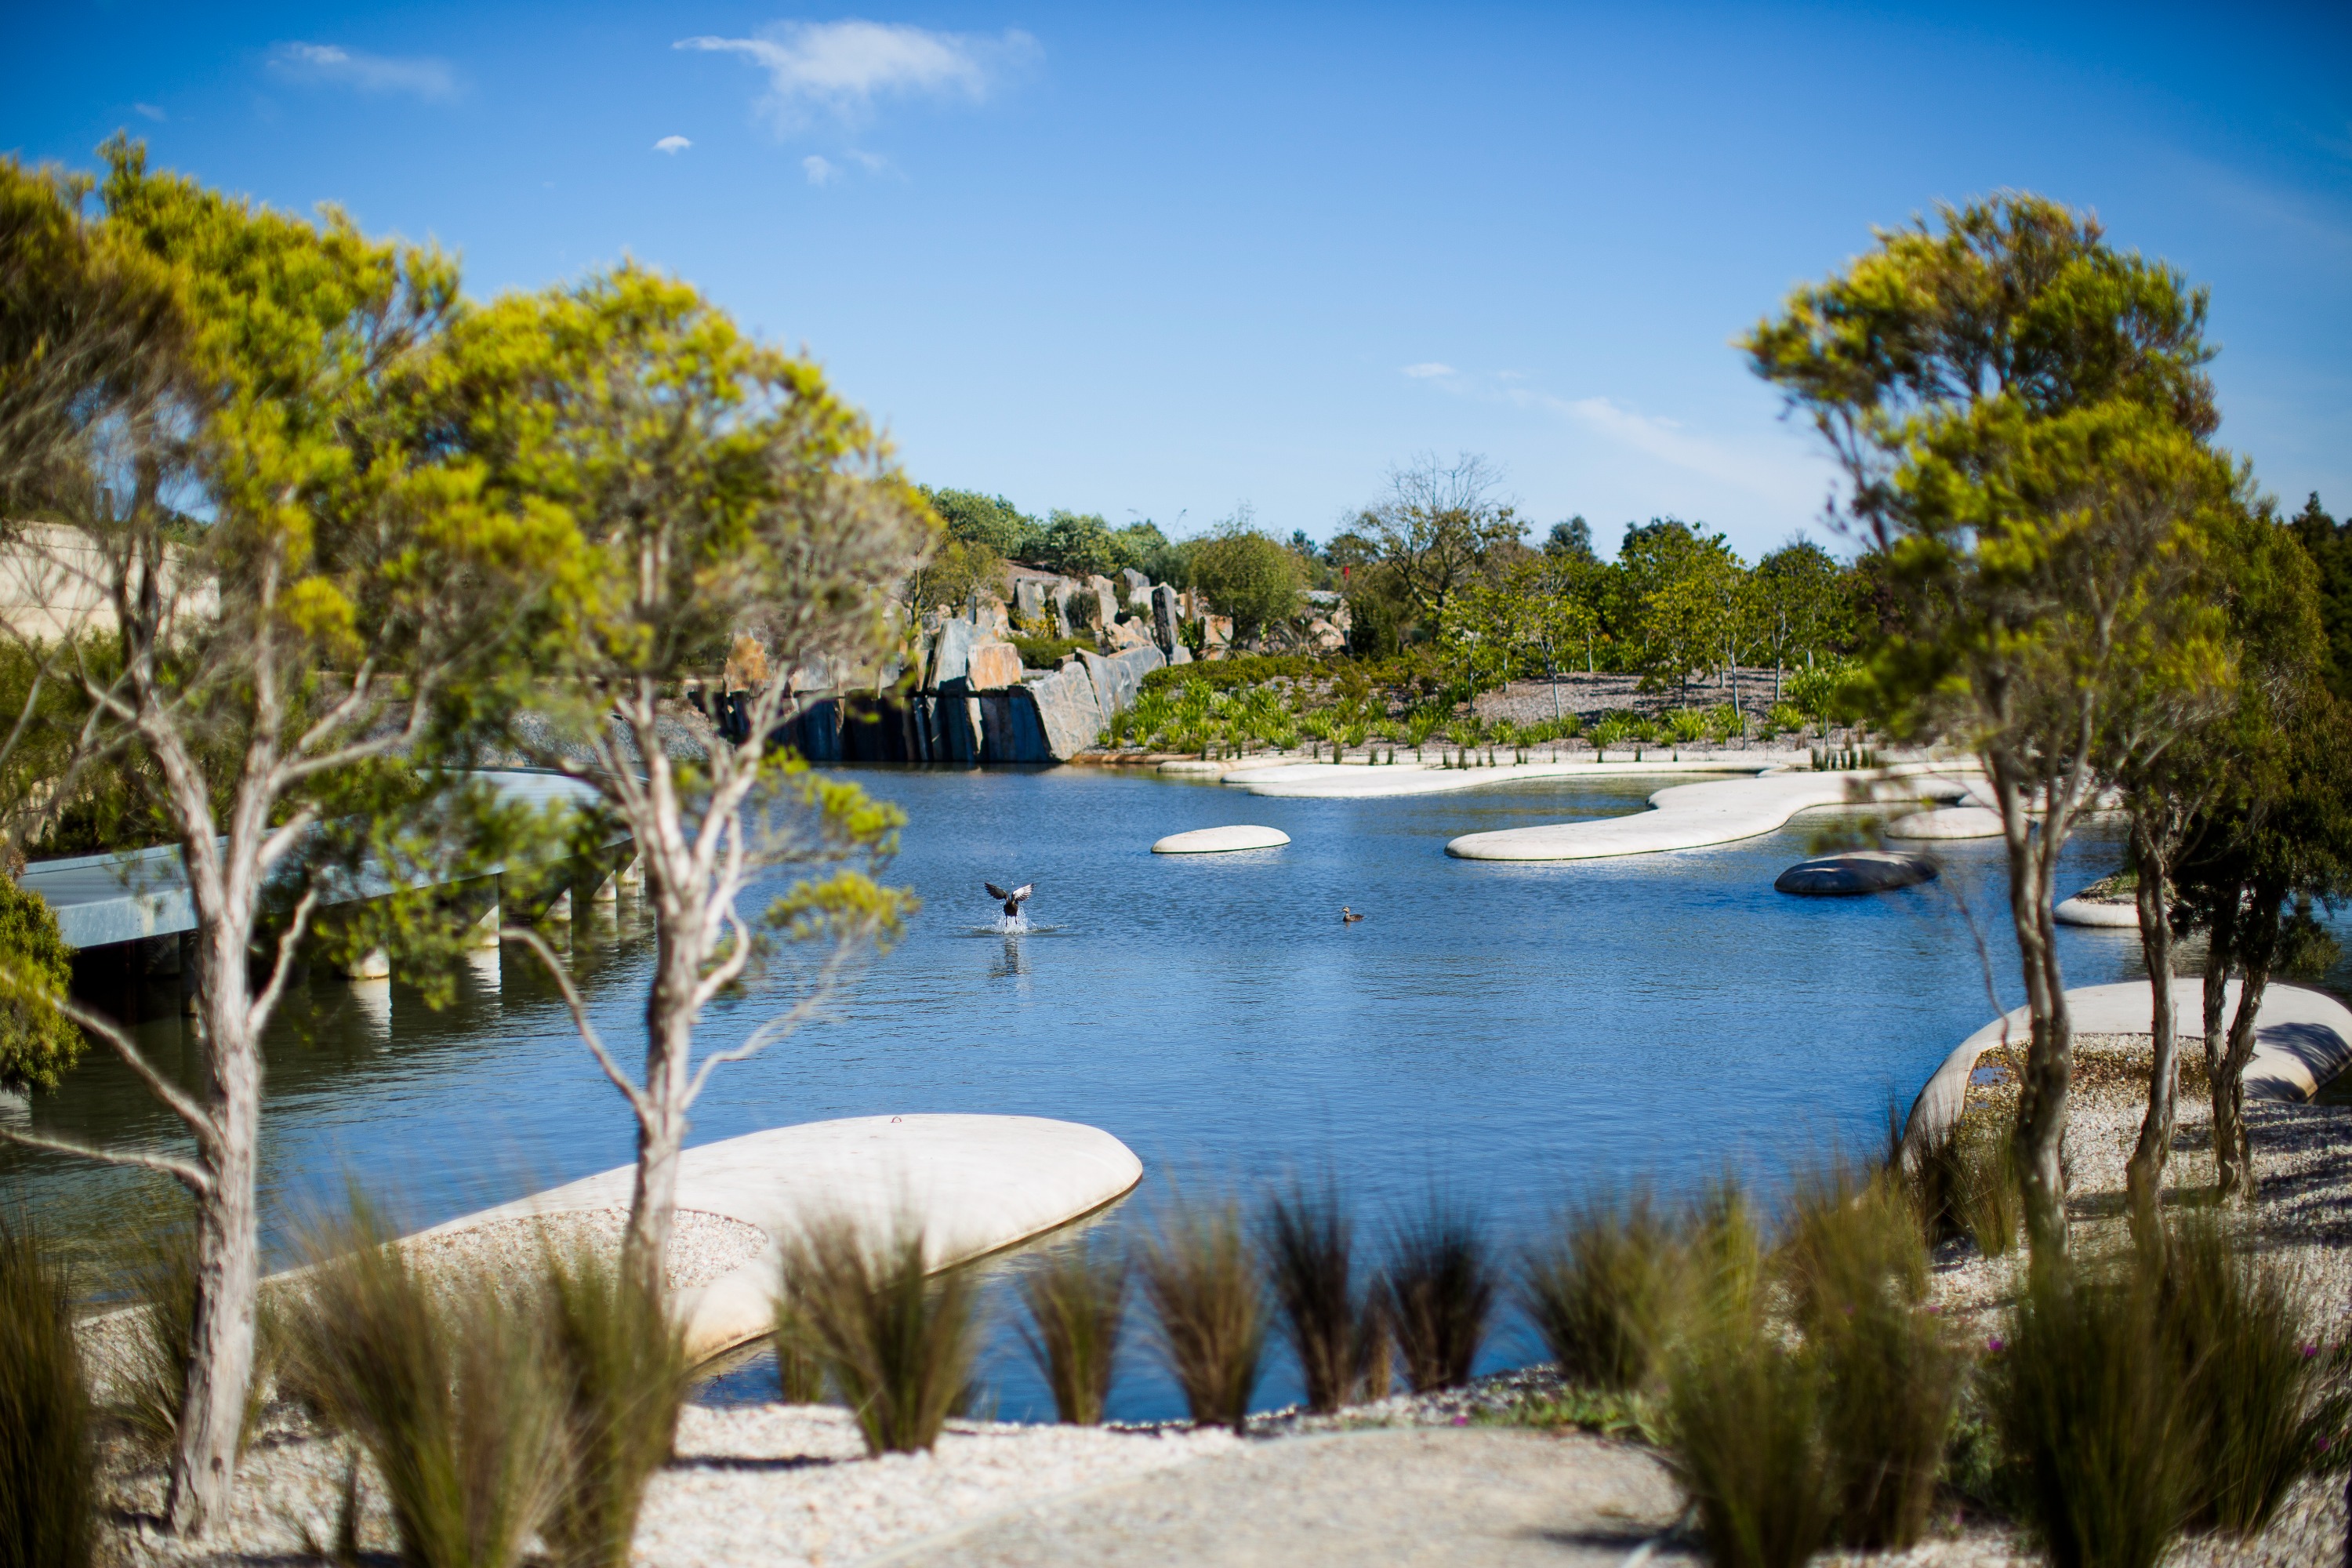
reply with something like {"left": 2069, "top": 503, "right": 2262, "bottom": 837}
{"left": 449, "top": 266, "right": 936, "bottom": 1293}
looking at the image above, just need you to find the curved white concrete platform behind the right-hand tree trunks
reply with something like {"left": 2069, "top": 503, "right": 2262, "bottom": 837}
{"left": 1903, "top": 975, "right": 2352, "bottom": 1152}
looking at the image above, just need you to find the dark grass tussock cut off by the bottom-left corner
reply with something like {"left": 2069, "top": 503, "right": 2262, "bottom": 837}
{"left": 0, "top": 1213, "right": 96, "bottom": 1568}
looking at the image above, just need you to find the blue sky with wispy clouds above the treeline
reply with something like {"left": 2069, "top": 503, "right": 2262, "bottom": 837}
{"left": 0, "top": 0, "right": 2352, "bottom": 555}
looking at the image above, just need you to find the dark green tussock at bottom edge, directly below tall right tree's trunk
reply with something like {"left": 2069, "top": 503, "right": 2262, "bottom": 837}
{"left": 1987, "top": 1265, "right": 2204, "bottom": 1568}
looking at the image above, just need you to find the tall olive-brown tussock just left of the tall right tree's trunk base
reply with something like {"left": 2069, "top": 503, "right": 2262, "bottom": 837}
{"left": 1778, "top": 1168, "right": 1969, "bottom": 1552}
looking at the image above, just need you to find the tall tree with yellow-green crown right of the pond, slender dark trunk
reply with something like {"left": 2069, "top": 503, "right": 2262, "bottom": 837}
{"left": 1743, "top": 195, "right": 2225, "bottom": 1255}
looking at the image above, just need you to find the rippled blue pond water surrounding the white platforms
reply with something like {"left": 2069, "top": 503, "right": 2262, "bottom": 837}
{"left": 0, "top": 769, "right": 2164, "bottom": 1417}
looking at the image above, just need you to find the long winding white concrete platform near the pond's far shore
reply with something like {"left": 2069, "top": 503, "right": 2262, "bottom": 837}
{"left": 1446, "top": 764, "right": 1964, "bottom": 860}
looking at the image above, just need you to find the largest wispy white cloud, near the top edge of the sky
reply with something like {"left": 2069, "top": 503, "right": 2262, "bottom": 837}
{"left": 670, "top": 19, "right": 1037, "bottom": 129}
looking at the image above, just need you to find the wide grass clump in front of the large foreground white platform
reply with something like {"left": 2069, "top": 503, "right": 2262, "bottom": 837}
{"left": 779, "top": 1218, "right": 978, "bottom": 1453}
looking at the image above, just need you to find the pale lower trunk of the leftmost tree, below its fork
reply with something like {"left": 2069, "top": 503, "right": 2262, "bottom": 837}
{"left": 165, "top": 921, "right": 261, "bottom": 1535}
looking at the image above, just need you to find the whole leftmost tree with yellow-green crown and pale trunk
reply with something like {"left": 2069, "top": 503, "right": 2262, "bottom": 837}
{"left": 0, "top": 141, "right": 529, "bottom": 1533}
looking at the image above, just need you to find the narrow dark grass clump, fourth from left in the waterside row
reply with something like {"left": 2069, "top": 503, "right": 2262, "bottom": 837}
{"left": 1265, "top": 1180, "right": 1395, "bottom": 1415}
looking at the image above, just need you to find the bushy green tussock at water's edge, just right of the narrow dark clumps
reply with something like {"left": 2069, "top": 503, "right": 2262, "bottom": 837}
{"left": 1519, "top": 1189, "right": 1679, "bottom": 1392}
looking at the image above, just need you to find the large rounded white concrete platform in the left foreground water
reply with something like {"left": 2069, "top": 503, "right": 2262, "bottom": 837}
{"left": 405, "top": 1116, "right": 1143, "bottom": 1361}
